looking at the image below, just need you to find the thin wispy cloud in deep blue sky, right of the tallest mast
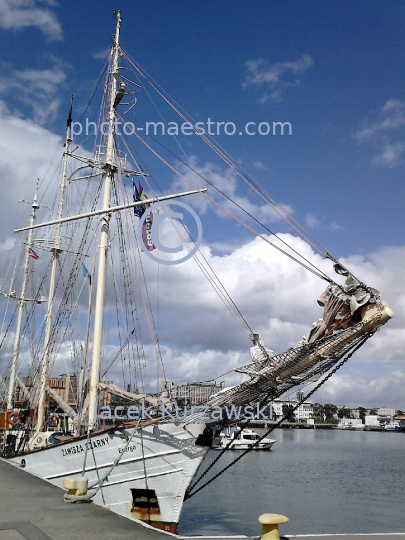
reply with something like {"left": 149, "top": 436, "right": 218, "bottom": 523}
{"left": 242, "top": 54, "right": 313, "bottom": 103}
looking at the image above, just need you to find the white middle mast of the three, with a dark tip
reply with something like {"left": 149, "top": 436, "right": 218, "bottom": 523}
{"left": 36, "top": 96, "right": 73, "bottom": 432}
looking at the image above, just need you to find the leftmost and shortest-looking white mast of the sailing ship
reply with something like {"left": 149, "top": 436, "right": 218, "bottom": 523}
{"left": 7, "top": 194, "right": 39, "bottom": 411}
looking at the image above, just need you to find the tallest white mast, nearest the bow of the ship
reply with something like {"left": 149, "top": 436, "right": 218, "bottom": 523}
{"left": 89, "top": 11, "right": 121, "bottom": 429}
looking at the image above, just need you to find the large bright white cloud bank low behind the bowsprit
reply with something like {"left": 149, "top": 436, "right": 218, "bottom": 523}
{"left": 120, "top": 234, "right": 405, "bottom": 407}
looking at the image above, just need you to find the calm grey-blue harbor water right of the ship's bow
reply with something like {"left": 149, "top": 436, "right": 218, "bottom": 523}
{"left": 178, "top": 429, "right": 405, "bottom": 536}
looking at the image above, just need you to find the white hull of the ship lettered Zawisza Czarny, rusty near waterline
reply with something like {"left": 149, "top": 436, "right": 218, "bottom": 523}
{"left": 9, "top": 424, "right": 208, "bottom": 532}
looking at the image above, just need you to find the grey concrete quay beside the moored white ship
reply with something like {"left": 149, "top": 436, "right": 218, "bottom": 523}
{"left": 0, "top": 459, "right": 405, "bottom": 540}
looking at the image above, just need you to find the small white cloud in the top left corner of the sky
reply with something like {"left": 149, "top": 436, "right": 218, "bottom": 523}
{"left": 0, "top": 0, "right": 62, "bottom": 40}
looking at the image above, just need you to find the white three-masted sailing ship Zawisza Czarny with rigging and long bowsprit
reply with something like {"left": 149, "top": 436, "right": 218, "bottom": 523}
{"left": 0, "top": 11, "right": 393, "bottom": 532}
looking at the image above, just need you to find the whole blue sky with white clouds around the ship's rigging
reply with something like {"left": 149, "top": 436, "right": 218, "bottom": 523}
{"left": 0, "top": 0, "right": 405, "bottom": 409}
